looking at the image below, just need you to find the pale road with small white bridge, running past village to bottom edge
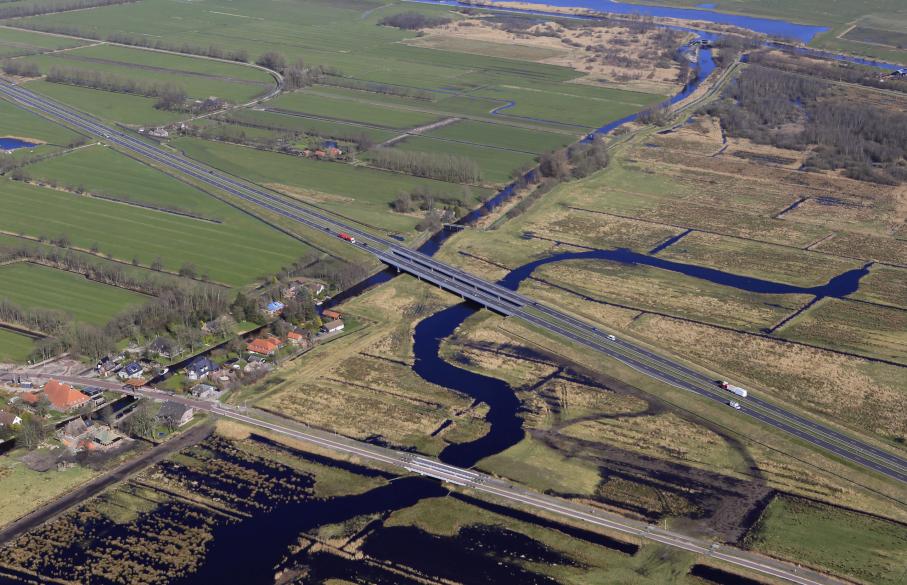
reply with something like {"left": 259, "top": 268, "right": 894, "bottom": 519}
{"left": 2, "top": 369, "right": 844, "bottom": 585}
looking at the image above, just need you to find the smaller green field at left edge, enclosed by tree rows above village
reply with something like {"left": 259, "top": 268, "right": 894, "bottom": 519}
{"left": 0, "top": 262, "right": 148, "bottom": 325}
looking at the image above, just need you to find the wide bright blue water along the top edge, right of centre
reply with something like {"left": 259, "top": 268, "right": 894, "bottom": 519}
{"left": 414, "top": 0, "right": 828, "bottom": 43}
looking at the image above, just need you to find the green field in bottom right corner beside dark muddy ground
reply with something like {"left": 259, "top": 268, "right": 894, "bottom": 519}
{"left": 747, "top": 496, "right": 907, "bottom": 585}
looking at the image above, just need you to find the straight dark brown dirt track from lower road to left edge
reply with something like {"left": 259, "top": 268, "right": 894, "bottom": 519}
{"left": 0, "top": 423, "right": 214, "bottom": 546}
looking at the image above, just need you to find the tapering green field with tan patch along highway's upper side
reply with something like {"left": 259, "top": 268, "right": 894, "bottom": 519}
{"left": 173, "top": 138, "right": 490, "bottom": 231}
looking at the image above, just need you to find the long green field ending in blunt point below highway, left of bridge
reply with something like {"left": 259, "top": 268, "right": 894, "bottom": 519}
{"left": 0, "top": 181, "right": 307, "bottom": 286}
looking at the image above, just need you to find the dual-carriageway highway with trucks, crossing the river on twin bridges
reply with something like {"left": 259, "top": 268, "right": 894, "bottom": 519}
{"left": 0, "top": 81, "right": 907, "bottom": 483}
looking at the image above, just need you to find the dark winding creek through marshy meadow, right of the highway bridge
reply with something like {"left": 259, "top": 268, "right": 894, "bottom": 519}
{"left": 499, "top": 248, "right": 872, "bottom": 298}
